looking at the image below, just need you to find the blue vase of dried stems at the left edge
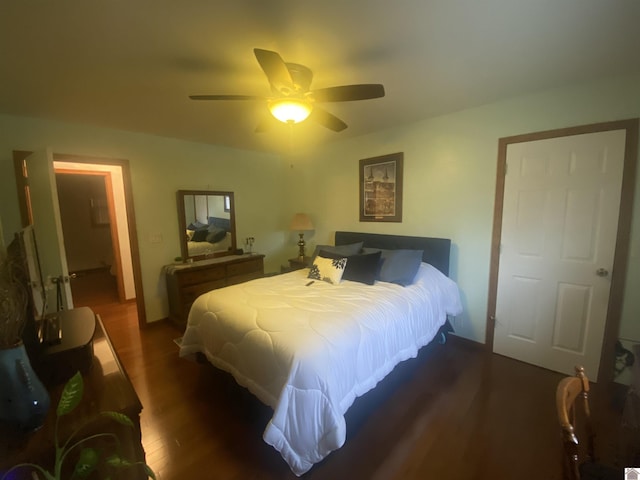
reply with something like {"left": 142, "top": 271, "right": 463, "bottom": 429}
{"left": 0, "top": 244, "right": 49, "bottom": 431}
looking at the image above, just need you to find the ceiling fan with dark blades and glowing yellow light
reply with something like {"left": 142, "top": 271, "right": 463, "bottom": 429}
{"left": 189, "top": 48, "right": 384, "bottom": 132}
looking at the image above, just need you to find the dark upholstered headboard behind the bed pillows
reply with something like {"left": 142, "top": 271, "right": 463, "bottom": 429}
{"left": 335, "top": 232, "right": 451, "bottom": 276}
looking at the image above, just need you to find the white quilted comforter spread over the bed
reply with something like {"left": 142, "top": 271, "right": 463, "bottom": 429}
{"left": 180, "top": 263, "right": 462, "bottom": 475}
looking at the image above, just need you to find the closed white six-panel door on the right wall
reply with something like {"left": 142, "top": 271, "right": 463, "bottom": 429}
{"left": 494, "top": 130, "right": 625, "bottom": 379}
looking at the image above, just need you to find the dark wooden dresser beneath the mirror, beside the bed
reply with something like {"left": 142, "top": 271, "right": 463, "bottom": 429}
{"left": 165, "top": 253, "right": 264, "bottom": 327}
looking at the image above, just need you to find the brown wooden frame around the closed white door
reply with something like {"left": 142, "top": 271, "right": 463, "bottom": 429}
{"left": 485, "top": 118, "right": 639, "bottom": 382}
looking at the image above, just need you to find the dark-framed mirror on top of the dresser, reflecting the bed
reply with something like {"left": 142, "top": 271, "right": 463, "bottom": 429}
{"left": 177, "top": 190, "right": 236, "bottom": 260}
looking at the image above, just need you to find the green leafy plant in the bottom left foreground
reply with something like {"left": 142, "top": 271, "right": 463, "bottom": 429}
{"left": 0, "top": 372, "right": 156, "bottom": 480}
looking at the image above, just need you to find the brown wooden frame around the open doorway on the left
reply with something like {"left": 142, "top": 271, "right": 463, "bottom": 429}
{"left": 13, "top": 150, "right": 147, "bottom": 328}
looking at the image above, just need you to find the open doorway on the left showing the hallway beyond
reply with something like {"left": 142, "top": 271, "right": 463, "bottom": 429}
{"left": 53, "top": 159, "right": 137, "bottom": 318}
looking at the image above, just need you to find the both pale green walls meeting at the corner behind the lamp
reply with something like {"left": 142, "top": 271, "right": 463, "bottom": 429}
{"left": 0, "top": 75, "right": 640, "bottom": 352}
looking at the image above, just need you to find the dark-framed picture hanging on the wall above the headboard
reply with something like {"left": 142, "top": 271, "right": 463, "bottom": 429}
{"left": 359, "top": 152, "right": 404, "bottom": 222}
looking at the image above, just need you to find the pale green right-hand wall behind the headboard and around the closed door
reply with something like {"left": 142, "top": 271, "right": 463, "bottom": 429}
{"left": 293, "top": 76, "right": 640, "bottom": 343}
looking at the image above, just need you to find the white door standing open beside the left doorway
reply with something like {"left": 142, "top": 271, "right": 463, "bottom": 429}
{"left": 26, "top": 151, "right": 73, "bottom": 312}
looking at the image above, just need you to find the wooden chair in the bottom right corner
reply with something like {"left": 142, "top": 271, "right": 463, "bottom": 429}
{"left": 556, "top": 366, "right": 623, "bottom": 480}
